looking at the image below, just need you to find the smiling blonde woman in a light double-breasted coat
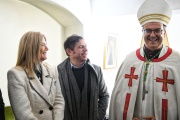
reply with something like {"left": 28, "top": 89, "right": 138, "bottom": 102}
{"left": 7, "top": 31, "right": 65, "bottom": 120}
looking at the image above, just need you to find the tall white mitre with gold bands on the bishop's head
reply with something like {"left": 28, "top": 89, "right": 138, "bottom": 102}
{"left": 137, "top": 0, "right": 172, "bottom": 26}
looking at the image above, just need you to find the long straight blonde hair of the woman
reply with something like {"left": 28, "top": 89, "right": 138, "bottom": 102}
{"left": 16, "top": 31, "right": 46, "bottom": 78}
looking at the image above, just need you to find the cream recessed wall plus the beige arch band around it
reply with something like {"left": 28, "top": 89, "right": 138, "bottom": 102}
{"left": 0, "top": 0, "right": 83, "bottom": 106}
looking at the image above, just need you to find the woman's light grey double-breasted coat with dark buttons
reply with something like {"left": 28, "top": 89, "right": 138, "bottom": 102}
{"left": 7, "top": 63, "right": 65, "bottom": 120}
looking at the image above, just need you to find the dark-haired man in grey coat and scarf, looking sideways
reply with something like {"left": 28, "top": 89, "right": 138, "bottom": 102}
{"left": 57, "top": 35, "right": 109, "bottom": 120}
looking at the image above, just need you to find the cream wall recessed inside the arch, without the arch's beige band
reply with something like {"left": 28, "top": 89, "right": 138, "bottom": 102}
{"left": 0, "top": 0, "right": 64, "bottom": 106}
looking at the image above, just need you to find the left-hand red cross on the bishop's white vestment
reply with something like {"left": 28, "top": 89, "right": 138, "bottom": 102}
{"left": 125, "top": 67, "right": 138, "bottom": 87}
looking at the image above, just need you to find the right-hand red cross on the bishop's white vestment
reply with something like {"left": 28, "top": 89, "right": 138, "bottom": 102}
{"left": 156, "top": 69, "right": 174, "bottom": 92}
